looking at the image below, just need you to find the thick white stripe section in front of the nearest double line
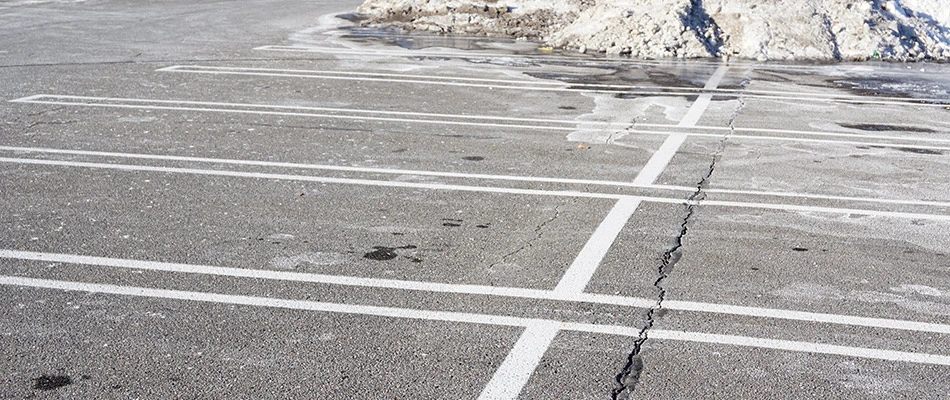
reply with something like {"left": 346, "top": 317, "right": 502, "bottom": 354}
{"left": 478, "top": 322, "right": 560, "bottom": 400}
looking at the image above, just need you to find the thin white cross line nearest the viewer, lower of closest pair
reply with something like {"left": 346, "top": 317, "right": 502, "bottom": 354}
{"left": 0, "top": 275, "right": 950, "bottom": 365}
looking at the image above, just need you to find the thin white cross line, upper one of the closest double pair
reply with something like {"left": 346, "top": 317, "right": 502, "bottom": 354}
{"left": 7, "top": 249, "right": 950, "bottom": 334}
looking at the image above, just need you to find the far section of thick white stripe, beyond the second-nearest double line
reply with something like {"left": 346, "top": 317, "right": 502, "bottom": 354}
{"left": 633, "top": 65, "right": 729, "bottom": 185}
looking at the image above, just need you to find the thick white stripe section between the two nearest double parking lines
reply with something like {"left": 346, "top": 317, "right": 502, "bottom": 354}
{"left": 554, "top": 197, "right": 640, "bottom": 293}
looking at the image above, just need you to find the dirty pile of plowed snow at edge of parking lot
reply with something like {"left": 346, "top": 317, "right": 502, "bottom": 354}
{"left": 357, "top": 0, "right": 950, "bottom": 61}
